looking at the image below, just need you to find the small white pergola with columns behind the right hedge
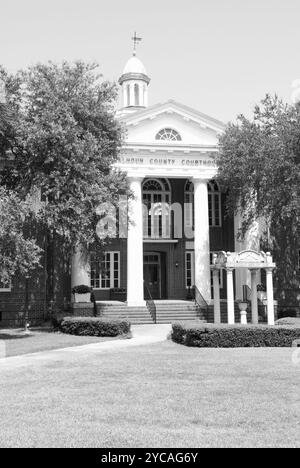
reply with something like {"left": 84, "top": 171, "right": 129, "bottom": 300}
{"left": 211, "top": 250, "right": 276, "bottom": 325}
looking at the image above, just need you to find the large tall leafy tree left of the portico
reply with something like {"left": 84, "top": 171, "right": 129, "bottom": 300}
{"left": 4, "top": 62, "right": 127, "bottom": 308}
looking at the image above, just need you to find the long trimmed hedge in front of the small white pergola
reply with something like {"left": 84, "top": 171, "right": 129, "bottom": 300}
{"left": 172, "top": 323, "right": 300, "bottom": 348}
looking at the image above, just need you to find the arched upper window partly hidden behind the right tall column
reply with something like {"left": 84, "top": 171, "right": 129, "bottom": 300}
{"left": 184, "top": 180, "right": 222, "bottom": 228}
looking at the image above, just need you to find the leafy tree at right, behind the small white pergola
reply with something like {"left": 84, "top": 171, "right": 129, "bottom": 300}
{"left": 218, "top": 95, "right": 300, "bottom": 306}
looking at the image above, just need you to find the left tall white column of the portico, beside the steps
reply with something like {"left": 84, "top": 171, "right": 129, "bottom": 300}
{"left": 127, "top": 177, "right": 145, "bottom": 307}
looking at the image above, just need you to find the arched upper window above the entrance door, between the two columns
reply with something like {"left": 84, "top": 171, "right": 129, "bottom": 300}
{"left": 143, "top": 179, "right": 171, "bottom": 239}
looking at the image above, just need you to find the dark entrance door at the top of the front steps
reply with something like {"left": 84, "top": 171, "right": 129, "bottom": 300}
{"left": 144, "top": 252, "right": 161, "bottom": 299}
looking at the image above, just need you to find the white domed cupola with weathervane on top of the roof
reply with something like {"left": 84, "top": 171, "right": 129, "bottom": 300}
{"left": 119, "top": 33, "right": 150, "bottom": 110}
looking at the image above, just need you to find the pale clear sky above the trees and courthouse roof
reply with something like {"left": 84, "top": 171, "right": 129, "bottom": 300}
{"left": 0, "top": 0, "right": 300, "bottom": 122}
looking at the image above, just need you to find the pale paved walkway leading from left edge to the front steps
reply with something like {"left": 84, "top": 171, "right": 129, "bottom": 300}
{"left": 0, "top": 324, "right": 171, "bottom": 371}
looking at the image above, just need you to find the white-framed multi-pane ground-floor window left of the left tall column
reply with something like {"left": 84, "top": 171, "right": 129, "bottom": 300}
{"left": 91, "top": 252, "right": 120, "bottom": 289}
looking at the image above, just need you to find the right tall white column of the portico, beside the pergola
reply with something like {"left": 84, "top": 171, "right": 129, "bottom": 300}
{"left": 193, "top": 179, "right": 211, "bottom": 302}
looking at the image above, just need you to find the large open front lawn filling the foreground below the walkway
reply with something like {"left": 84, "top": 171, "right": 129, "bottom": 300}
{"left": 0, "top": 341, "right": 300, "bottom": 448}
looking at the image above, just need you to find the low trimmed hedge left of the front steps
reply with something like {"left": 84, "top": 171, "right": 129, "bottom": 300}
{"left": 59, "top": 317, "right": 131, "bottom": 337}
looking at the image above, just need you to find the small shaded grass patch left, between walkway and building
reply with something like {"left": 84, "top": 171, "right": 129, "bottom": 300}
{"left": 0, "top": 328, "right": 120, "bottom": 357}
